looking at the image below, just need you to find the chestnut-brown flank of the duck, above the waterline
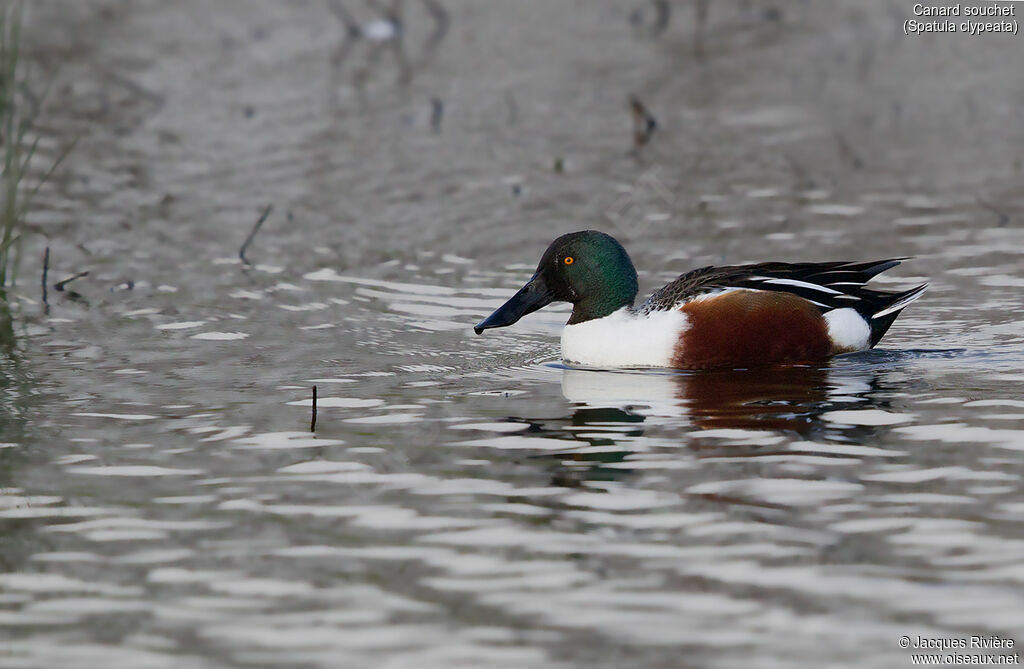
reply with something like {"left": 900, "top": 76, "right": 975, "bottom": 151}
{"left": 672, "top": 290, "right": 831, "bottom": 369}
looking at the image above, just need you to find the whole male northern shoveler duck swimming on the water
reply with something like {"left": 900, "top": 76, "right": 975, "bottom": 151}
{"left": 473, "top": 231, "right": 928, "bottom": 369}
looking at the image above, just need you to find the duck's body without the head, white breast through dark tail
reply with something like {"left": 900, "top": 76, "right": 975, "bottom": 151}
{"left": 562, "top": 258, "right": 927, "bottom": 369}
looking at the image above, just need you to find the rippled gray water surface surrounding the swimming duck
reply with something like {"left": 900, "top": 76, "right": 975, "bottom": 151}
{"left": 0, "top": 0, "right": 1024, "bottom": 669}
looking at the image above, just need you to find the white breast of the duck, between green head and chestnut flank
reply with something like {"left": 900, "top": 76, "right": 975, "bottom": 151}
{"left": 562, "top": 306, "right": 686, "bottom": 369}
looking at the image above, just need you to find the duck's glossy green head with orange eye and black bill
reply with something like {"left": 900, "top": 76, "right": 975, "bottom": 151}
{"left": 473, "top": 229, "right": 638, "bottom": 334}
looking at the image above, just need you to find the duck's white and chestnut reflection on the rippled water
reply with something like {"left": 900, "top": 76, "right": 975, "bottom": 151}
{"left": 529, "top": 366, "right": 885, "bottom": 486}
